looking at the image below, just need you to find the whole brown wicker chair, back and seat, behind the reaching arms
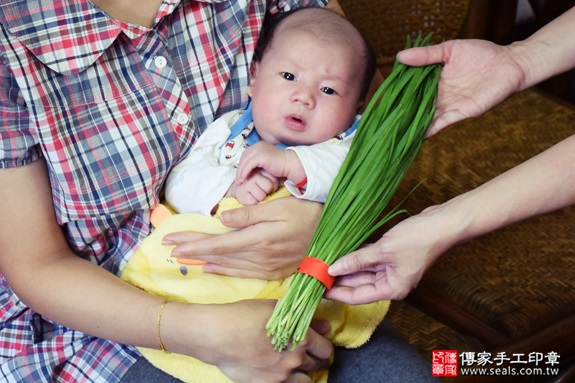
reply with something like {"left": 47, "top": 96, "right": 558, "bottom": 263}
{"left": 339, "top": 0, "right": 575, "bottom": 383}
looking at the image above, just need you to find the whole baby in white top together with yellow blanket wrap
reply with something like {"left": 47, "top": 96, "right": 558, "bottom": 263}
{"left": 122, "top": 8, "right": 389, "bottom": 383}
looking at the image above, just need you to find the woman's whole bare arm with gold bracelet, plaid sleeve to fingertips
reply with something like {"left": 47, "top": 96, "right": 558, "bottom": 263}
{"left": 0, "top": 160, "right": 332, "bottom": 382}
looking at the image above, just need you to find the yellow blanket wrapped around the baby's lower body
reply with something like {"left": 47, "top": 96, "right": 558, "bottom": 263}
{"left": 121, "top": 192, "right": 389, "bottom": 383}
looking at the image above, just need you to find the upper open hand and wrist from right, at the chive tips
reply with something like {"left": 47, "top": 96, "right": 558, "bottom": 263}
{"left": 397, "top": 8, "right": 575, "bottom": 136}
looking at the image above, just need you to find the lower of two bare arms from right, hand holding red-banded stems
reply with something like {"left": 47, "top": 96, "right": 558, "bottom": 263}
{"left": 327, "top": 136, "right": 575, "bottom": 304}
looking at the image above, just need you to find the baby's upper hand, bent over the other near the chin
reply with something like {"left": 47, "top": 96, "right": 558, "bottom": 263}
{"left": 236, "top": 141, "right": 291, "bottom": 185}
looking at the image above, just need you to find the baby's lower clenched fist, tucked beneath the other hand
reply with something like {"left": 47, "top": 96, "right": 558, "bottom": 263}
{"left": 228, "top": 171, "right": 279, "bottom": 206}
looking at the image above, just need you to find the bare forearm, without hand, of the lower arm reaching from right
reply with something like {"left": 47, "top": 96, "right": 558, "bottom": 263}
{"left": 439, "top": 136, "right": 575, "bottom": 242}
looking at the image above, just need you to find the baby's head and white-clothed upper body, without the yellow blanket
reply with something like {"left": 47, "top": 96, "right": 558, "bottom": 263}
{"left": 165, "top": 9, "right": 376, "bottom": 214}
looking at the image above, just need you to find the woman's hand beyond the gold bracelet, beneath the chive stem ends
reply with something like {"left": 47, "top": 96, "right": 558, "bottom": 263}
{"left": 162, "top": 300, "right": 333, "bottom": 383}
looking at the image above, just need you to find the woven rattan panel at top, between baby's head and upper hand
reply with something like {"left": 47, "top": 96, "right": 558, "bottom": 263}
{"left": 339, "top": 0, "right": 470, "bottom": 65}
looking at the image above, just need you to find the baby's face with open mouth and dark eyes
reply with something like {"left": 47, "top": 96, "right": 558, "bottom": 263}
{"left": 249, "top": 30, "right": 363, "bottom": 145}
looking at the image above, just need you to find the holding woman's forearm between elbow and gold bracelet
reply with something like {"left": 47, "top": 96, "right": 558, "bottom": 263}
{"left": 14, "top": 255, "right": 172, "bottom": 348}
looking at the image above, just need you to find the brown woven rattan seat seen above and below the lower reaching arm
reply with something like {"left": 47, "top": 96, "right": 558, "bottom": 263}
{"left": 397, "top": 90, "right": 575, "bottom": 339}
